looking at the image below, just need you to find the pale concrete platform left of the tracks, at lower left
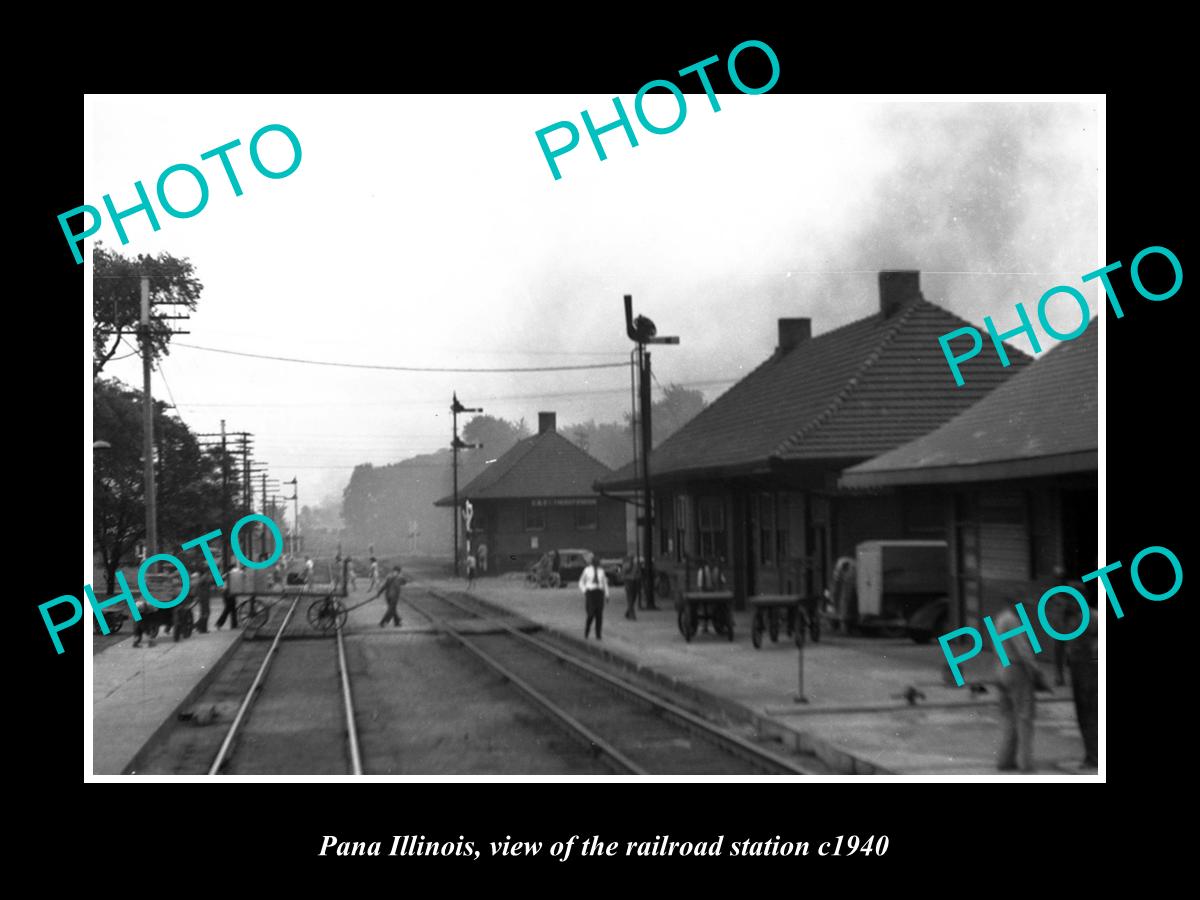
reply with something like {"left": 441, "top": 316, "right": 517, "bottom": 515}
{"left": 91, "top": 630, "right": 242, "bottom": 775}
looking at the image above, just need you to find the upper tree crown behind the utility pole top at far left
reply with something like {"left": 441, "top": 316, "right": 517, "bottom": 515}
{"left": 91, "top": 242, "right": 204, "bottom": 377}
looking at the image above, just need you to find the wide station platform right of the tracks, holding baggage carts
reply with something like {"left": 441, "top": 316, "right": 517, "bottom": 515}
{"left": 416, "top": 576, "right": 1094, "bottom": 776}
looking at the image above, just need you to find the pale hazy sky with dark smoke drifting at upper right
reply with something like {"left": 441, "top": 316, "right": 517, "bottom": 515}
{"left": 82, "top": 94, "right": 1109, "bottom": 511}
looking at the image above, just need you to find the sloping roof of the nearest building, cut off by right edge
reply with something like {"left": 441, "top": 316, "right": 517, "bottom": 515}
{"left": 841, "top": 319, "right": 1099, "bottom": 487}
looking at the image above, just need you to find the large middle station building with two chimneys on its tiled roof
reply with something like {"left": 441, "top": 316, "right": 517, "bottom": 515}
{"left": 598, "top": 271, "right": 1030, "bottom": 607}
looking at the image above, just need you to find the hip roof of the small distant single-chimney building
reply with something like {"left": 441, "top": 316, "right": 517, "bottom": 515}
{"left": 433, "top": 428, "right": 612, "bottom": 506}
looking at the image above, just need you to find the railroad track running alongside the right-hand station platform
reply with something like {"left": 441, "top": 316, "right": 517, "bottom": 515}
{"left": 404, "top": 588, "right": 814, "bottom": 775}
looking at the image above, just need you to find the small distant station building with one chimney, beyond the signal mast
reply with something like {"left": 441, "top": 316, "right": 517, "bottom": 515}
{"left": 434, "top": 413, "right": 625, "bottom": 572}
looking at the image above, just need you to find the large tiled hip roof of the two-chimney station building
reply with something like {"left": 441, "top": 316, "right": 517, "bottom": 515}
{"left": 600, "top": 282, "right": 1031, "bottom": 490}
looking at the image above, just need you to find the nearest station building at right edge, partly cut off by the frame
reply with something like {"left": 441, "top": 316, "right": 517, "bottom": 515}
{"left": 841, "top": 319, "right": 1099, "bottom": 626}
